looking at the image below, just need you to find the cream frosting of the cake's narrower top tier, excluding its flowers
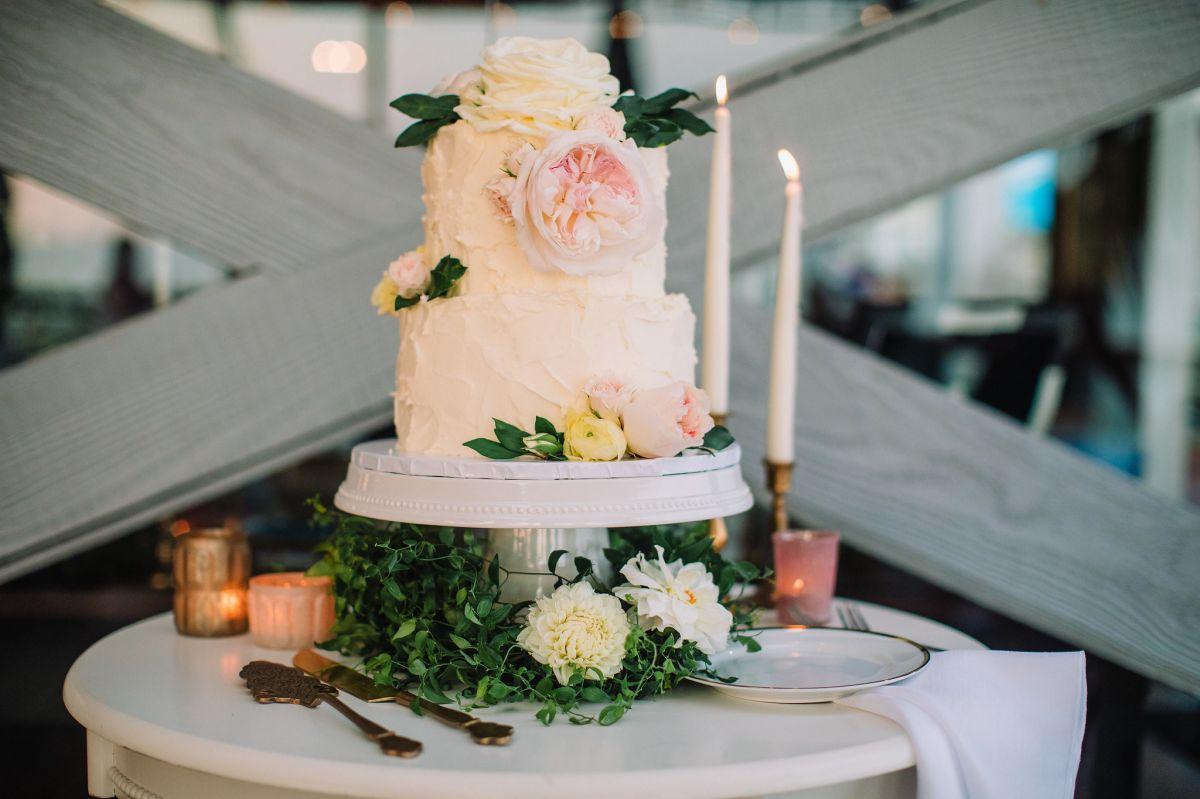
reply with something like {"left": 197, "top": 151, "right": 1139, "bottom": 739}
{"left": 421, "top": 120, "right": 667, "bottom": 296}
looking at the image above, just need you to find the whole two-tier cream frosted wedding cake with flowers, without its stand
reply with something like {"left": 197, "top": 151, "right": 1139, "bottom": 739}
{"left": 372, "top": 38, "right": 713, "bottom": 461}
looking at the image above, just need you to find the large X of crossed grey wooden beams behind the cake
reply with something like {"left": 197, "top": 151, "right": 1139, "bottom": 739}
{"left": 0, "top": 0, "right": 1200, "bottom": 691}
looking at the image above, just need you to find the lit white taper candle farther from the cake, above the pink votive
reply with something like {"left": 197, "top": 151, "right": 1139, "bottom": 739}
{"left": 767, "top": 150, "right": 804, "bottom": 463}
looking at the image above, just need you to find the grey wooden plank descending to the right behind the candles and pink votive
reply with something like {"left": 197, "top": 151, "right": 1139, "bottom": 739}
{"left": 730, "top": 307, "right": 1200, "bottom": 692}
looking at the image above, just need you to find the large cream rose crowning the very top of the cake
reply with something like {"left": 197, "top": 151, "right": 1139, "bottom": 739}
{"left": 455, "top": 36, "right": 619, "bottom": 137}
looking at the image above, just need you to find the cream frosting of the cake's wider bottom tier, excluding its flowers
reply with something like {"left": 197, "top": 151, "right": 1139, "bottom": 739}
{"left": 395, "top": 294, "right": 696, "bottom": 457}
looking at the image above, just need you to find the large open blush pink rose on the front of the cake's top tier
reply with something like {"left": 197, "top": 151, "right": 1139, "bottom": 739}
{"left": 509, "top": 131, "right": 665, "bottom": 276}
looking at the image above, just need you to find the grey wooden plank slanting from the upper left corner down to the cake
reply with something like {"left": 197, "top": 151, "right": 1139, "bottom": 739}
{"left": 0, "top": 0, "right": 420, "bottom": 269}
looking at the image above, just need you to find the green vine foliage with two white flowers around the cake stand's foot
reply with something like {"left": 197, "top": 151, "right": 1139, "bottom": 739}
{"left": 304, "top": 500, "right": 766, "bottom": 725}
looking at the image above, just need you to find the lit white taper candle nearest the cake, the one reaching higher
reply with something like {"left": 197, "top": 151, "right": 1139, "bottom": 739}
{"left": 701, "top": 74, "right": 732, "bottom": 416}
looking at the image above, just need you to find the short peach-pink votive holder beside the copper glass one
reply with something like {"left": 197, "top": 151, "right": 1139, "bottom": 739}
{"left": 248, "top": 571, "right": 334, "bottom": 649}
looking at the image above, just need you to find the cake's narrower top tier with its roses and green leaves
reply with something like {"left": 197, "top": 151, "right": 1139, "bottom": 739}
{"left": 372, "top": 37, "right": 709, "bottom": 313}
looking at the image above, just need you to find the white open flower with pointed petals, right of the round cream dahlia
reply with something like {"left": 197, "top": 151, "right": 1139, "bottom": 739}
{"left": 612, "top": 547, "right": 733, "bottom": 655}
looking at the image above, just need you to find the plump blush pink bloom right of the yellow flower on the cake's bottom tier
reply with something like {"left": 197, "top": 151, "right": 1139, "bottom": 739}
{"left": 622, "top": 380, "right": 713, "bottom": 458}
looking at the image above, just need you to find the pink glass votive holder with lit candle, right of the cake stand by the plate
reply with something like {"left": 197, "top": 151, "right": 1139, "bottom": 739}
{"left": 772, "top": 530, "right": 840, "bottom": 625}
